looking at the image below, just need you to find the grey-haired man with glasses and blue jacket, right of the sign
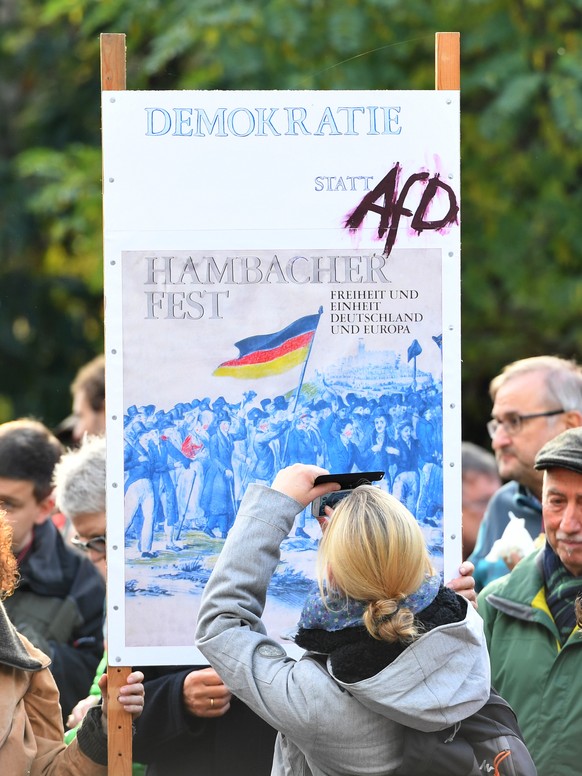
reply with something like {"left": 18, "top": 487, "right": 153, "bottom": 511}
{"left": 469, "top": 356, "right": 582, "bottom": 591}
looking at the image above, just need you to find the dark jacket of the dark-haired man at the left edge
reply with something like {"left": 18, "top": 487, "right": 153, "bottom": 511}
{"left": 4, "top": 520, "right": 105, "bottom": 719}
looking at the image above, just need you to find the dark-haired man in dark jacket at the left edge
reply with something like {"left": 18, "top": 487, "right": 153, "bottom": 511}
{"left": 0, "top": 418, "right": 105, "bottom": 719}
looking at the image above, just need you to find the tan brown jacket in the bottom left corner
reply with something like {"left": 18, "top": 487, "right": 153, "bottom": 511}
{"left": 0, "top": 604, "right": 107, "bottom": 776}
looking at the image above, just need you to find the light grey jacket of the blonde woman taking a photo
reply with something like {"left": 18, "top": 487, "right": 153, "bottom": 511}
{"left": 196, "top": 484, "right": 490, "bottom": 776}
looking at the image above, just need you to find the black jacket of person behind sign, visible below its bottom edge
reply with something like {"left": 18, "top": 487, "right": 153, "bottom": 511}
{"left": 133, "top": 666, "right": 276, "bottom": 776}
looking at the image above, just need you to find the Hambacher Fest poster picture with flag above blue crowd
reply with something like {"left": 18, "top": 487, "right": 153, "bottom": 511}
{"left": 118, "top": 250, "right": 443, "bottom": 646}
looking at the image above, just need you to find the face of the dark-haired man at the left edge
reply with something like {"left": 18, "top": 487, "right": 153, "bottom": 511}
{"left": 0, "top": 477, "right": 54, "bottom": 553}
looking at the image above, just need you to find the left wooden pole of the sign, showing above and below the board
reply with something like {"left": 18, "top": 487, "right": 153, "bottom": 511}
{"left": 100, "top": 33, "right": 132, "bottom": 776}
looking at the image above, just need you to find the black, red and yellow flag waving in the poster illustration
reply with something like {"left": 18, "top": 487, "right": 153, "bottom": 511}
{"left": 212, "top": 312, "right": 321, "bottom": 379}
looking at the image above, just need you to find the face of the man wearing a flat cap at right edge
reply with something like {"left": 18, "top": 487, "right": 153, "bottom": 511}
{"left": 542, "top": 469, "right": 582, "bottom": 577}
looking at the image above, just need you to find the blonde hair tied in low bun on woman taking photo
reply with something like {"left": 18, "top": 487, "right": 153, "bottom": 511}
{"left": 317, "top": 485, "right": 434, "bottom": 642}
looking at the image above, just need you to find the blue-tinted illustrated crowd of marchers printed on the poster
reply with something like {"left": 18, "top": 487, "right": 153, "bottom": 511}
{"left": 124, "top": 385, "right": 443, "bottom": 558}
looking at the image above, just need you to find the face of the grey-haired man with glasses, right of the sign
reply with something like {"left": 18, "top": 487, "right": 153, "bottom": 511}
{"left": 491, "top": 372, "right": 568, "bottom": 494}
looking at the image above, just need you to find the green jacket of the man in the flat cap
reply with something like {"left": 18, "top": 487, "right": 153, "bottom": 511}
{"left": 478, "top": 553, "right": 582, "bottom": 776}
